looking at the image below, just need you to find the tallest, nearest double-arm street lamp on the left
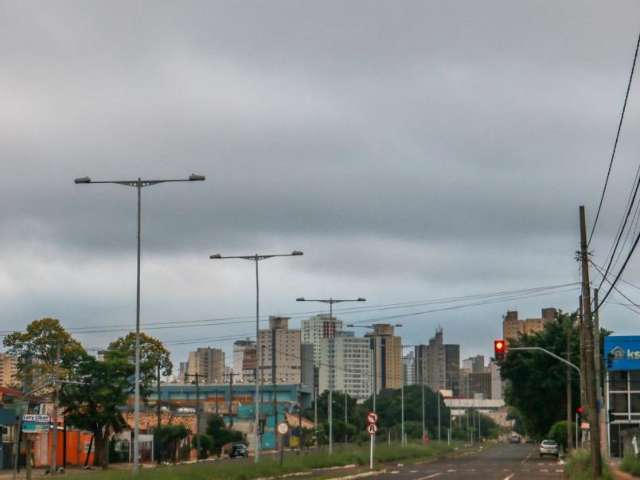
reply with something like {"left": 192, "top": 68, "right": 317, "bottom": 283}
{"left": 74, "top": 174, "right": 205, "bottom": 473}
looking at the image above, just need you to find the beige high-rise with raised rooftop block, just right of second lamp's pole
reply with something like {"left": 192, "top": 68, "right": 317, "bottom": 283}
{"left": 259, "top": 317, "right": 302, "bottom": 384}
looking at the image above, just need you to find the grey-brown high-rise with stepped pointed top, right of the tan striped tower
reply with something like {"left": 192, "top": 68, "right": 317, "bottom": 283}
{"left": 414, "top": 327, "right": 460, "bottom": 396}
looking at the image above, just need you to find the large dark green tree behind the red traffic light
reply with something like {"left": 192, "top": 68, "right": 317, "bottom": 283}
{"left": 501, "top": 313, "right": 580, "bottom": 438}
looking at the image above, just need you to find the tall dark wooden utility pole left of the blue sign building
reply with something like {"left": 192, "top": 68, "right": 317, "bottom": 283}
{"left": 580, "top": 206, "right": 602, "bottom": 478}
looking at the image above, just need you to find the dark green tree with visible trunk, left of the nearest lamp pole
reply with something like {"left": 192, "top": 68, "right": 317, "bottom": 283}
{"left": 60, "top": 352, "right": 133, "bottom": 468}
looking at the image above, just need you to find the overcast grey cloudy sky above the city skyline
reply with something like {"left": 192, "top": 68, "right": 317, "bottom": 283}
{"left": 0, "top": 0, "right": 640, "bottom": 372}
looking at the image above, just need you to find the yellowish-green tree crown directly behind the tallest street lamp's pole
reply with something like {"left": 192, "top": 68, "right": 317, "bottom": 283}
{"left": 108, "top": 332, "right": 173, "bottom": 398}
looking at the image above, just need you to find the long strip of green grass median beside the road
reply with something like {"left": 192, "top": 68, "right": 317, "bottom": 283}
{"left": 63, "top": 442, "right": 455, "bottom": 480}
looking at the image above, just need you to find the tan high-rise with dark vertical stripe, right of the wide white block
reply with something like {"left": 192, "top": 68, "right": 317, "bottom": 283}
{"left": 366, "top": 323, "right": 403, "bottom": 392}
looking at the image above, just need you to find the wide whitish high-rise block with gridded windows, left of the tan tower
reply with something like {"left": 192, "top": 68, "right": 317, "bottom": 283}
{"left": 318, "top": 332, "right": 372, "bottom": 400}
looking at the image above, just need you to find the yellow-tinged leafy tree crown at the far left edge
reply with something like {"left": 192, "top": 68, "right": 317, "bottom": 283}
{"left": 3, "top": 318, "right": 86, "bottom": 383}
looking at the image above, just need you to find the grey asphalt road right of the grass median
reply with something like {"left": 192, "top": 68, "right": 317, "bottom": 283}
{"left": 372, "top": 444, "right": 564, "bottom": 480}
